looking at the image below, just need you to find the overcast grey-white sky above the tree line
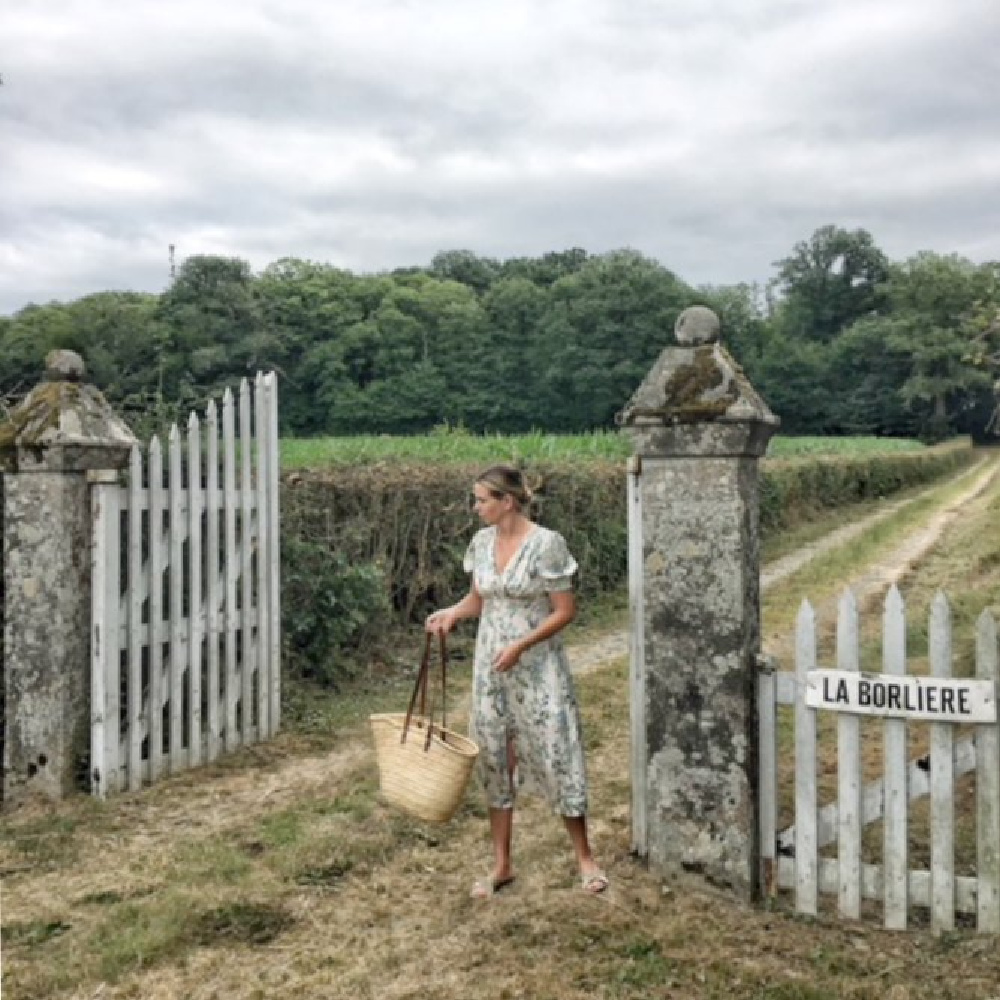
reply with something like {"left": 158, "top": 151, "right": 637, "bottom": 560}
{"left": 0, "top": 0, "right": 1000, "bottom": 314}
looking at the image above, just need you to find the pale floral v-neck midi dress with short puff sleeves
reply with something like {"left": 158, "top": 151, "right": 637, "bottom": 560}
{"left": 465, "top": 525, "right": 587, "bottom": 816}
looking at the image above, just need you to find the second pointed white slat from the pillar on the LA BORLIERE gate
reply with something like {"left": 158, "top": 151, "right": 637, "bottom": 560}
{"left": 837, "top": 589, "right": 861, "bottom": 920}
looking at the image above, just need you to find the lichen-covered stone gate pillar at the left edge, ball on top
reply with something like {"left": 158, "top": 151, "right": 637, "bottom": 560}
{"left": 0, "top": 351, "right": 135, "bottom": 805}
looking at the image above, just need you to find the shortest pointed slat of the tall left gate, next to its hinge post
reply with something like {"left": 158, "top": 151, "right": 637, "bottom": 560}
{"left": 125, "top": 445, "right": 150, "bottom": 792}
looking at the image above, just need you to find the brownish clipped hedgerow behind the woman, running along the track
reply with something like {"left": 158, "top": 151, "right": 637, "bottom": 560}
{"left": 281, "top": 441, "right": 974, "bottom": 683}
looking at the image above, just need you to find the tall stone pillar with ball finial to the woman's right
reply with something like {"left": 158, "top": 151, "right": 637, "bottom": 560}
{"left": 619, "top": 306, "right": 778, "bottom": 898}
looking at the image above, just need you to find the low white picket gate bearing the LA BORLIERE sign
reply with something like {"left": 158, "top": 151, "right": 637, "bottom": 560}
{"left": 758, "top": 587, "right": 1000, "bottom": 933}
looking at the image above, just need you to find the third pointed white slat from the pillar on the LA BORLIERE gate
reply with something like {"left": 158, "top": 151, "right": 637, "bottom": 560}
{"left": 882, "top": 585, "right": 909, "bottom": 930}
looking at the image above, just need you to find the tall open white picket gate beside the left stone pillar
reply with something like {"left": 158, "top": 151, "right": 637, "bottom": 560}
{"left": 91, "top": 373, "right": 281, "bottom": 797}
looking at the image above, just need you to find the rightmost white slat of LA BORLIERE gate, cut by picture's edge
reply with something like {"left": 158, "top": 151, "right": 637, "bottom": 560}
{"left": 975, "top": 608, "right": 1000, "bottom": 934}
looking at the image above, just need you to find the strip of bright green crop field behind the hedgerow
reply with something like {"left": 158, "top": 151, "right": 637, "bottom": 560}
{"left": 281, "top": 429, "right": 924, "bottom": 469}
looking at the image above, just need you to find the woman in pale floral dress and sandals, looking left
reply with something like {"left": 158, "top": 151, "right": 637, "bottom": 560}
{"left": 426, "top": 465, "right": 608, "bottom": 897}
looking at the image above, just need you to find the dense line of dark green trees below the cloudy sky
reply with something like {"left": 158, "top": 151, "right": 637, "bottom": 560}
{"left": 0, "top": 226, "right": 1000, "bottom": 440}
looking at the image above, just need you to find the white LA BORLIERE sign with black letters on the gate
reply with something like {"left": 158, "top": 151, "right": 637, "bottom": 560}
{"left": 806, "top": 670, "right": 997, "bottom": 722}
